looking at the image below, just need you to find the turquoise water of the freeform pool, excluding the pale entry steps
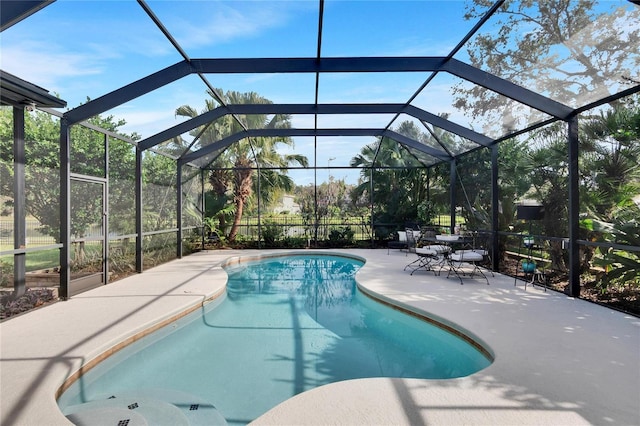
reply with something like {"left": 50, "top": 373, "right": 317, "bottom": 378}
{"left": 58, "top": 255, "right": 491, "bottom": 424}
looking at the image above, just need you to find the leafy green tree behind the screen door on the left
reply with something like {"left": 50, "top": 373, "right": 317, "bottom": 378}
{"left": 0, "top": 108, "right": 139, "bottom": 262}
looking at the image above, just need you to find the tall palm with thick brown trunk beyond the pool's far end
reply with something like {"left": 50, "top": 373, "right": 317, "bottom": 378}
{"left": 176, "top": 90, "right": 308, "bottom": 241}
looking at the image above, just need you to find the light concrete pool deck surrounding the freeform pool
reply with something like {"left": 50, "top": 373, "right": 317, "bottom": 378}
{"left": 0, "top": 249, "right": 640, "bottom": 426}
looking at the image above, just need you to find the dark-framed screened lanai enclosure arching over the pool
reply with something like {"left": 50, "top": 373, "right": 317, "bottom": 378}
{"left": 0, "top": 0, "right": 640, "bottom": 312}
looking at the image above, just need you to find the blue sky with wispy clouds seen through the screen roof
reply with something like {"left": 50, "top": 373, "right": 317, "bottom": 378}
{"left": 0, "top": 0, "right": 636, "bottom": 184}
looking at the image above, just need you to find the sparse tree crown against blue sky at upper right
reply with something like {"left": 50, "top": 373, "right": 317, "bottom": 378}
{"left": 454, "top": 0, "right": 640, "bottom": 133}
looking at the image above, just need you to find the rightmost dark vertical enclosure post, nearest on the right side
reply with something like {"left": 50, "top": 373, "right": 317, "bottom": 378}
{"left": 567, "top": 115, "right": 580, "bottom": 297}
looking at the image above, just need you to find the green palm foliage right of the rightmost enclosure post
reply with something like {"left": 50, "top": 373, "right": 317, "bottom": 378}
{"left": 580, "top": 97, "right": 640, "bottom": 291}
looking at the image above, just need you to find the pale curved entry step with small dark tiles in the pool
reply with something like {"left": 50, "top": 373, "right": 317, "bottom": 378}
{"left": 64, "top": 389, "right": 227, "bottom": 426}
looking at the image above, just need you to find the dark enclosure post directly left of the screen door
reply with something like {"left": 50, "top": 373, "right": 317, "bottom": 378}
{"left": 59, "top": 117, "right": 71, "bottom": 299}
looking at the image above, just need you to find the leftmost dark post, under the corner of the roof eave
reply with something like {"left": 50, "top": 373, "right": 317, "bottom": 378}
{"left": 13, "top": 106, "right": 27, "bottom": 298}
